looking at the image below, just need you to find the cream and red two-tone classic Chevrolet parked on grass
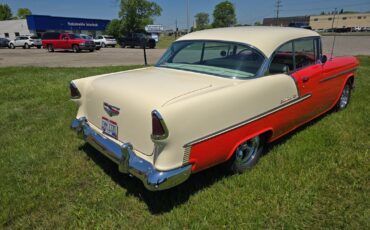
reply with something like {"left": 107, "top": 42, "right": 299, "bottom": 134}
{"left": 70, "top": 27, "right": 359, "bottom": 191}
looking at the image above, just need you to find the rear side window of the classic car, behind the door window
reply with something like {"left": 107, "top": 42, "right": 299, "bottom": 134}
{"left": 269, "top": 42, "right": 294, "bottom": 74}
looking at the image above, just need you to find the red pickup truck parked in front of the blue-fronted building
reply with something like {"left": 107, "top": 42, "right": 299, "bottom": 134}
{"left": 42, "top": 32, "right": 95, "bottom": 53}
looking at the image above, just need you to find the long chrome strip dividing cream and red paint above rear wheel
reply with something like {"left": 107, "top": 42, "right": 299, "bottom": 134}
{"left": 184, "top": 93, "right": 312, "bottom": 148}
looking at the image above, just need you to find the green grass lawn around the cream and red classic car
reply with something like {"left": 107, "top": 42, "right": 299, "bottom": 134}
{"left": 0, "top": 57, "right": 370, "bottom": 229}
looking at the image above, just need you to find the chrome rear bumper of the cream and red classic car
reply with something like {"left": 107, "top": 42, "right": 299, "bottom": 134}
{"left": 71, "top": 117, "right": 191, "bottom": 191}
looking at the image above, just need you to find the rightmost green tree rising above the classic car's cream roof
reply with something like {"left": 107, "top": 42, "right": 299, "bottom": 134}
{"left": 212, "top": 1, "right": 236, "bottom": 28}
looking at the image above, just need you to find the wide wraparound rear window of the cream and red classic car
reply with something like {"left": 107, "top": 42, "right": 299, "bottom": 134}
{"left": 156, "top": 41, "right": 265, "bottom": 78}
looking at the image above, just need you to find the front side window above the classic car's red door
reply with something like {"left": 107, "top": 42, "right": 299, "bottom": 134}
{"left": 294, "top": 38, "right": 317, "bottom": 69}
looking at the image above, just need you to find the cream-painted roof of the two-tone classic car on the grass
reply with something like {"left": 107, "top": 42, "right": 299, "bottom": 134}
{"left": 177, "top": 26, "right": 320, "bottom": 57}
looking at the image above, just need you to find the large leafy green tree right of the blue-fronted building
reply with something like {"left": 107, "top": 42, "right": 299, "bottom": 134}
{"left": 119, "top": 0, "right": 162, "bottom": 33}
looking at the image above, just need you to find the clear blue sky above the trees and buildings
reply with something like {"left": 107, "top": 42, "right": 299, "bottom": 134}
{"left": 0, "top": 0, "right": 370, "bottom": 29}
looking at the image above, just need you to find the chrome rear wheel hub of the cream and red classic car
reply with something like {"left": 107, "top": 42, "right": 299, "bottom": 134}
{"left": 236, "top": 136, "right": 260, "bottom": 164}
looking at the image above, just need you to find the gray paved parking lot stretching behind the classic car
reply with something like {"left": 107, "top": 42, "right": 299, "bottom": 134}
{"left": 0, "top": 36, "right": 370, "bottom": 67}
